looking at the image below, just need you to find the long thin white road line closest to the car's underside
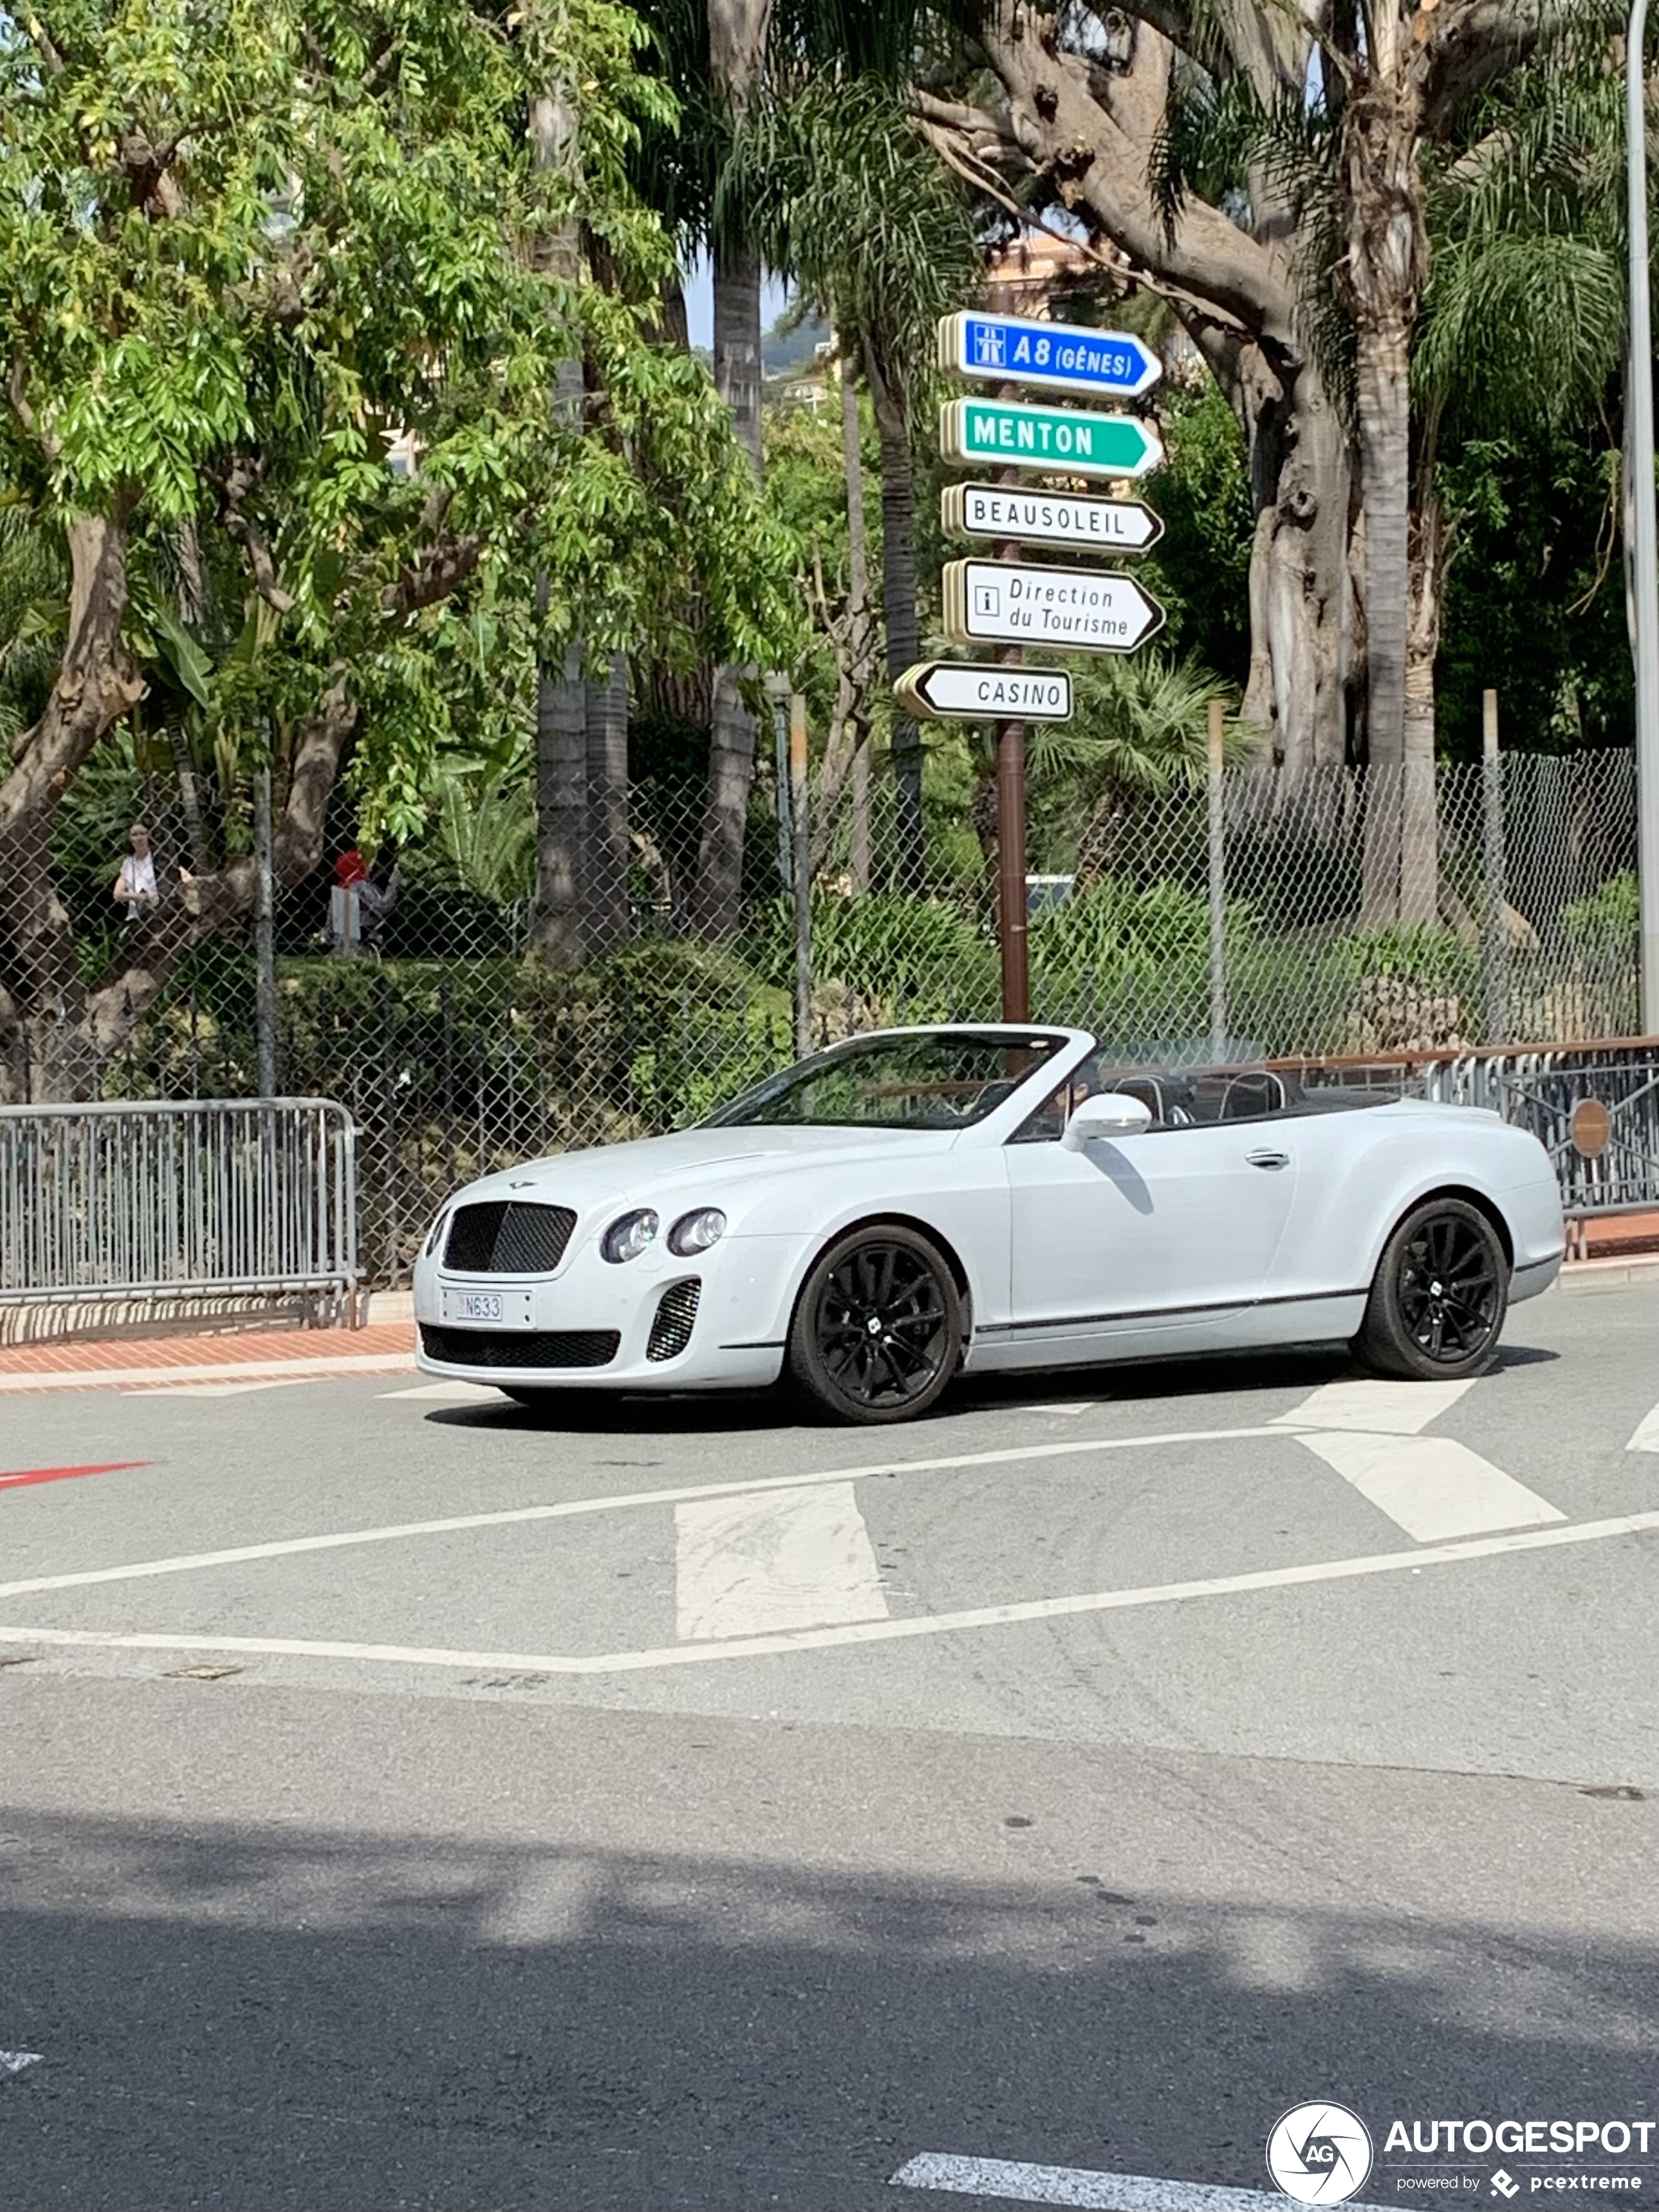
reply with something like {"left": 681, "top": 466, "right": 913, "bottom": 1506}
{"left": 0, "top": 1429, "right": 1283, "bottom": 1597}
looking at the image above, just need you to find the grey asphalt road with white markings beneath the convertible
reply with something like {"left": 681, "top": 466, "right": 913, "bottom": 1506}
{"left": 0, "top": 1285, "right": 1659, "bottom": 2212}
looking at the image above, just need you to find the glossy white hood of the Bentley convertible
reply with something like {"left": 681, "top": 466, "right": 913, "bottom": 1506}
{"left": 451, "top": 1128, "right": 958, "bottom": 1212}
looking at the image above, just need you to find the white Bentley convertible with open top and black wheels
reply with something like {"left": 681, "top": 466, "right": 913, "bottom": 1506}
{"left": 416, "top": 1024, "right": 1562, "bottom": 1422}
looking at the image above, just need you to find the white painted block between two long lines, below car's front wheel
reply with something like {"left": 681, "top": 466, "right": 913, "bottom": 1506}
{"left": 675, "top": 1482, "right": 887, "bottom": 1637}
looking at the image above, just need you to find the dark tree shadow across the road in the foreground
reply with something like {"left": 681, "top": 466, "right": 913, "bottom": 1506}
{"left": 0, "top": 1796, "right": 1659, "bottom": 2212}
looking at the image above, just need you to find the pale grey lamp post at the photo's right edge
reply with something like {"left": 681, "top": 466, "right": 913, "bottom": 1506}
{"left": 1624, "top": 0, "right": 1659, "bottom": 1038}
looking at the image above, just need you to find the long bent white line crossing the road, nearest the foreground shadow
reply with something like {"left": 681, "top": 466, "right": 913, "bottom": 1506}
{"left": 0, "top": 1513, "right": 1659, "bottom": 1675}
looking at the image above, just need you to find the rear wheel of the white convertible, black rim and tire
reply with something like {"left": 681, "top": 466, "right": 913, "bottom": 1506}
{"left": 1354, "top": 1199, "right": 1509, "bottom": 1383}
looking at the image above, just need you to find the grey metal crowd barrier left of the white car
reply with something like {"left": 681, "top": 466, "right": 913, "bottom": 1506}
{"left": 0, "top": 1099, "right": 359, "bottom": 1307}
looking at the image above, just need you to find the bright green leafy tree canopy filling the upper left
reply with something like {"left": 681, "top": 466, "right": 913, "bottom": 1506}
{"left": 0, "top": 0, "right": 799, "bottom": 839}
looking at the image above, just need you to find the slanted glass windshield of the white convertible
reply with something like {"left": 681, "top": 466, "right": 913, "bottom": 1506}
{"left": 713, "top": 1029, "right": 1066, "bottom": 1128}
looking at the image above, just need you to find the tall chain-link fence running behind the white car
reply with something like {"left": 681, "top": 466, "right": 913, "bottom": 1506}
{"left": 0, "top": 752, "right": 1639, "bottom": 1281}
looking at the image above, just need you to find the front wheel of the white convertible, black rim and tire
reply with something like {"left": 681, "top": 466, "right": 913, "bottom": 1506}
{"left": 788, "top": 1225, "right": 962, "bottom": 1424}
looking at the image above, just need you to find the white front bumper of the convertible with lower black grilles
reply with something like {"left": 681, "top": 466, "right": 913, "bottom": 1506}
{"left": 413, "top": 1236, "right": 805, "bottom": 1389}
